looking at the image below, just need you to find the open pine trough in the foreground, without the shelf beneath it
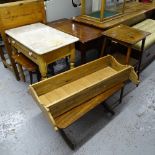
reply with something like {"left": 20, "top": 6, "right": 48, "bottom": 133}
{"left": 32, "top": 56, "right": 137, "bottom": 117}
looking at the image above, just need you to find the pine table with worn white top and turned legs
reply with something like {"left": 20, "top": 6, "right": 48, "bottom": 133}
{"left": 5, "top": 23, "right": 79, "bottom": 78}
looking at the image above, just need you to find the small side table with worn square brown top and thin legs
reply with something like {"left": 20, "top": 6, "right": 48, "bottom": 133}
{"left": 101, "top": 25, "right": 150, "bottom": 76}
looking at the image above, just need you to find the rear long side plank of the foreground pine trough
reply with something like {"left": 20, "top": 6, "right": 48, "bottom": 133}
{"left": 33, "top": 56, "right": 111, "bottom": 96}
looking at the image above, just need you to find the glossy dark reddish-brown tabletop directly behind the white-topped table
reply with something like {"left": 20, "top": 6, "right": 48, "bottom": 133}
{"left": 47, "top": 19, "right": 103, "bottom": 43}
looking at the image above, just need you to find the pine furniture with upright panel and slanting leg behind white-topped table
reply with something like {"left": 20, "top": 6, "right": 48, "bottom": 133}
{"left": 0, "top": 0, "right": 46, "bottom": 80}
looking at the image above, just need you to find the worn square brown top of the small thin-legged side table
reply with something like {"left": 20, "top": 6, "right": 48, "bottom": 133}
{"left": 102, "top": 24, "right": 151, "bottom": 45}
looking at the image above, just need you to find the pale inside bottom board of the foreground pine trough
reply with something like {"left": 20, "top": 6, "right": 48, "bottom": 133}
{"left": 39, "top": 67, "right": 117, "bottom": 105}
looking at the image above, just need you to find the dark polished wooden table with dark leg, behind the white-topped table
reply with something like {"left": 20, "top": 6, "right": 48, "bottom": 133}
{"left": 47, "top": 19, "right": 102, "bottom": 64}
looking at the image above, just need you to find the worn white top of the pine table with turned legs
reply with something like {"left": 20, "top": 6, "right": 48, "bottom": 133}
{"left": 5, "top": 23, "right": 79, "bottom": 55}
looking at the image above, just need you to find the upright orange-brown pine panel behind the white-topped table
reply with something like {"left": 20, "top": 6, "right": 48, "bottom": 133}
{"left": 0, "top": 0, "right": 46, "bottom": 29}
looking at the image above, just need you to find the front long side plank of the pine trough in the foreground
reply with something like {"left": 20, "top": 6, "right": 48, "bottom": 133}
{"left": 46, "top": 68, "right": 131, "bottom": 117}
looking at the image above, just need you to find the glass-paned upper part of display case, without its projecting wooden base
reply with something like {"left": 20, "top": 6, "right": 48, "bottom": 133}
{"left": 81, "top": 0, "right": 125, "bottom": 22}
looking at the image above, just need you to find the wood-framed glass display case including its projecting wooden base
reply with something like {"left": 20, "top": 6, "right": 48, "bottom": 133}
{"left": 73, "top": 0, "right": 126, "bottom": 28}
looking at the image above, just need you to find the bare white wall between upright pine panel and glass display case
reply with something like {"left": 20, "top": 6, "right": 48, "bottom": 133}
{"left": 46, "top": 0, "right": 80, "bottom": 22}
